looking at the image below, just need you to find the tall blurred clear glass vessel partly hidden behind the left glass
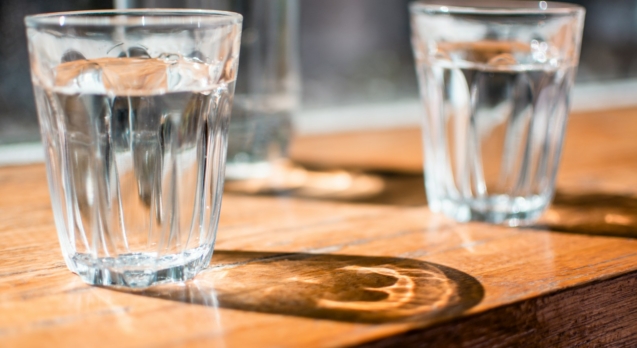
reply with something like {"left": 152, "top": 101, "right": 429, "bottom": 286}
{"left": 225, "top": 0, "right": 301, "bottom": 180}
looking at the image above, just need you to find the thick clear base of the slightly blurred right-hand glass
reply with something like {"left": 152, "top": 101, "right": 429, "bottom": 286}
{"left": 429, "top": 195, "right": 550, "bottom": 227}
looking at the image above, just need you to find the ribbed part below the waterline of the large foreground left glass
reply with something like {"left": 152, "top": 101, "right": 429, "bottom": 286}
{"left": 35, "top": 83, "right": 234, "bottom": 287}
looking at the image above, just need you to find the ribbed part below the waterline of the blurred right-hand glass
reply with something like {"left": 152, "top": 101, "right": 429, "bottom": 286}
{"left": 419, "top": 59, "right": 574, "bottom": 225}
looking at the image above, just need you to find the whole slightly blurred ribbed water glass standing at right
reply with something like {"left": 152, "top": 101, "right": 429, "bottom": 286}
{"left": 410, "top": 1, "right": 584, "bottom": 226}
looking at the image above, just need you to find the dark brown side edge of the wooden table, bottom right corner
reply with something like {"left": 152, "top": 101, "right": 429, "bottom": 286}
{"left": 361, "top": 272, "right": 637, "bottom": 348}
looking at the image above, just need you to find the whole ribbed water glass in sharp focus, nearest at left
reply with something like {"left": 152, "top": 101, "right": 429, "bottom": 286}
{"left": 25, "top": 10, "right": 242, "bottom": 287}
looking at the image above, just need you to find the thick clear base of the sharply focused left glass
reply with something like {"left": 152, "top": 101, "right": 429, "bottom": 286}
{"left": 68, "top": 246, "right": 212, "bottom": 289}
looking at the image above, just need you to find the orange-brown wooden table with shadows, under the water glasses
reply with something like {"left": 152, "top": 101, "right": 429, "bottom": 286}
{"left": 0, "top": 110, "right": 637, "bottom": 347}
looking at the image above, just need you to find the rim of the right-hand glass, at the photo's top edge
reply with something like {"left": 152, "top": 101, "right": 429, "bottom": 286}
{"left": 409, "top": 0, "right": 584, "bottom": 15}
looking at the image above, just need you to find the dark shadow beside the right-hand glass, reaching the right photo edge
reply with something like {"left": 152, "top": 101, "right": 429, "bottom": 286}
{"left": 538, "top": 191, "right": 637, "bottom": 238}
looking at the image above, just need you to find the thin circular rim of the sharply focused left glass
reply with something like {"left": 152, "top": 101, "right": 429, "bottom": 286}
{"left": 24, "top": 8, "right": 243, "bottom": 28}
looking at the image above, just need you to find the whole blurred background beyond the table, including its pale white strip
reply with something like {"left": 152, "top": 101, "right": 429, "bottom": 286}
{"left": 0, "top": 0, "right": 637, "bottom": 163}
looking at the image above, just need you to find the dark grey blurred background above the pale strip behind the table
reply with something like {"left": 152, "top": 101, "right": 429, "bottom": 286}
{"left": 0, "top": 0, "right": 637, "bottom": 144}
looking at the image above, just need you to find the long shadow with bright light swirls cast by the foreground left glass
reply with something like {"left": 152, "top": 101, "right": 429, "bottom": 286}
{"left": 120, "top": 250, "right": 484, "bottom": 323}
